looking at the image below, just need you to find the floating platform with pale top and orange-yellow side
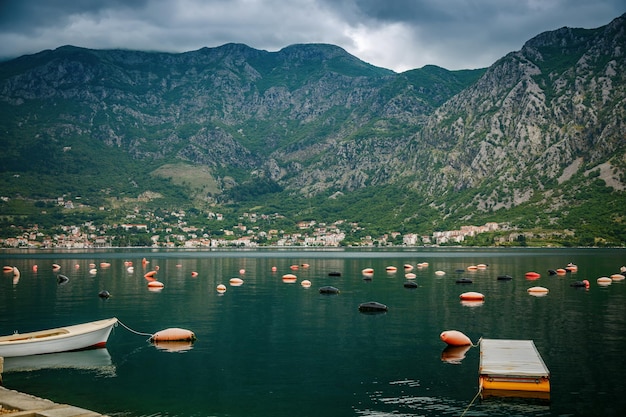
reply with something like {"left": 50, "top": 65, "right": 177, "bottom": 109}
{"left": 478, "top": 339, "right": 550, "bottom": 400}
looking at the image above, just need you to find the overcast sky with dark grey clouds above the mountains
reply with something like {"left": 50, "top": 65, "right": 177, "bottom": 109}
{"left": 0, "top": 0, "right": 626, "bottom": 72}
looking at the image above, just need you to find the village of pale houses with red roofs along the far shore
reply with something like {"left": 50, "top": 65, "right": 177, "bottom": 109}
{"left": 0, "top": 196, "right": 501, "bottom": 249}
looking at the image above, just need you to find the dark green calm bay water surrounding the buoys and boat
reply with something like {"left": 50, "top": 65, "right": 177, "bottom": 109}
{"left": 0, "top": 249, "right": 626, "bottom": 417}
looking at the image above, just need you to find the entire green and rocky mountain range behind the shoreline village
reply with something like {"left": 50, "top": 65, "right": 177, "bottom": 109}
{"left": 0, "top": 14, "right": 626, "bottom": 246}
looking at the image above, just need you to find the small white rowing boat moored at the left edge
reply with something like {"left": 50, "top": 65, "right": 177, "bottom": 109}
{"left": 0, "top": 318, "right": 117, "bottom": 358}
